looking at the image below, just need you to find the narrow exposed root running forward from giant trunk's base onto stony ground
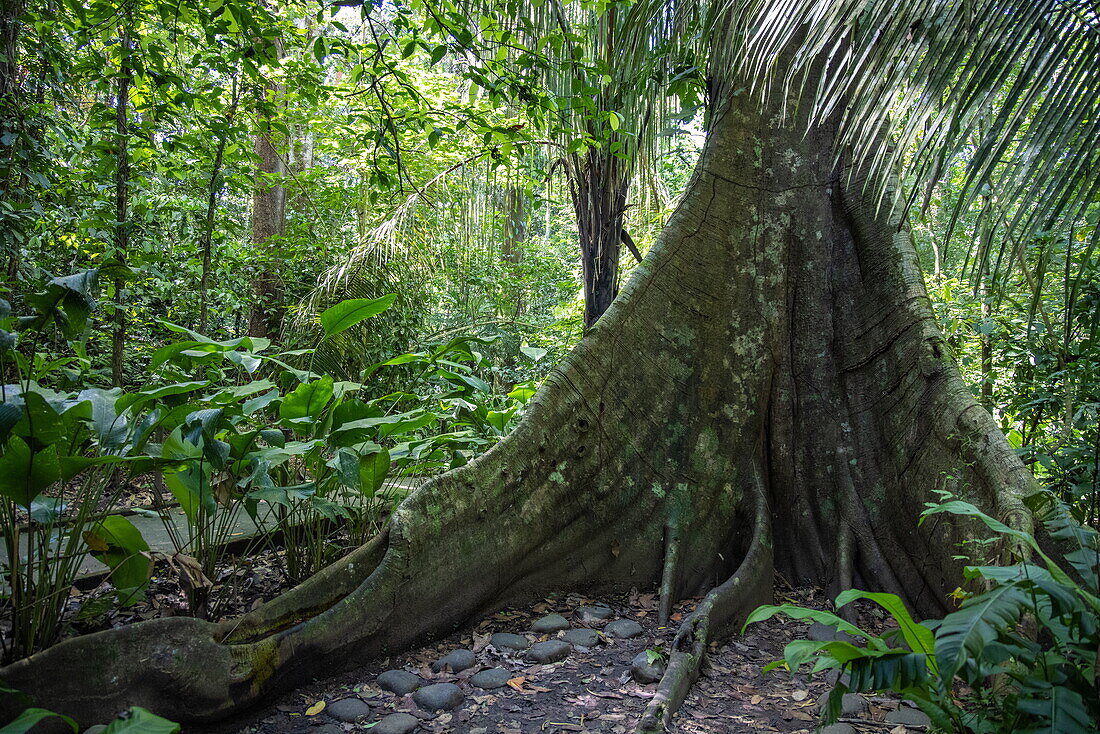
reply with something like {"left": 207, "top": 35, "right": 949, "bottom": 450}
{"left": 636, "top": 462, "right": 772, "bottom": 734}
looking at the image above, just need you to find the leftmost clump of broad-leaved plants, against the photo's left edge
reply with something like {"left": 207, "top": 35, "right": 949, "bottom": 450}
{"left": 0, "top": 271, "right": 151, "bottom": 660}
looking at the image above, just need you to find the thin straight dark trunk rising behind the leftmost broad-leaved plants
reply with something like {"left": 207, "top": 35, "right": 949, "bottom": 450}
{"left": 111, "top": 30, "right": 133, "bottom": 385}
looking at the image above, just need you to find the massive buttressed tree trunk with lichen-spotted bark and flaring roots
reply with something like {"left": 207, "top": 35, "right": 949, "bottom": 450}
{"left": 0, "top": 75, "right": 1033, "bottom": 732}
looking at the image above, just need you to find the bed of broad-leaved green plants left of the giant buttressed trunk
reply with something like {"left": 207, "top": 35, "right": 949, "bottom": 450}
{"left": 0, "top": 271, "right": 538, "bottom": 647}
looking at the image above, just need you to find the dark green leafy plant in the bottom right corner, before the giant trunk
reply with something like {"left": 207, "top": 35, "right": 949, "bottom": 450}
{"left": 746, "top": 492, "right": 1100, "bottom": 734}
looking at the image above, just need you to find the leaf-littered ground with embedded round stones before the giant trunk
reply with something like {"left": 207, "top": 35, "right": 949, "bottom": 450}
{"left": 210, "top": 589, "right": 925, "bottom": 734}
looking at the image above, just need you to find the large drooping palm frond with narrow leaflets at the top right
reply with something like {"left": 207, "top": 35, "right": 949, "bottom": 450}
{"left": 730, "top": 0, "right": 1100, "bottom": 274}
